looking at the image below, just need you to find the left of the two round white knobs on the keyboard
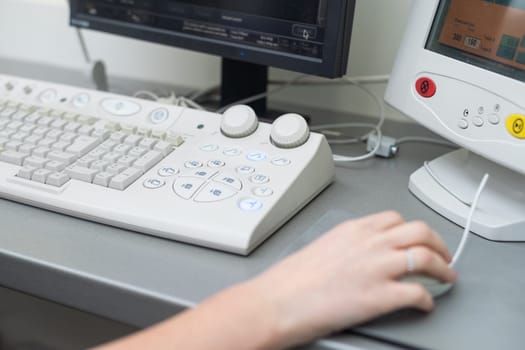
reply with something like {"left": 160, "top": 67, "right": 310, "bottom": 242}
{"left": 221, "top": 105, "right": 259, "bottom": 138}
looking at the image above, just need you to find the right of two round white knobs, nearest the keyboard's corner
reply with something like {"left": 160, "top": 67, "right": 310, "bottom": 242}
{"left": 271, "top": 113, "right": 310, "bottom": 148}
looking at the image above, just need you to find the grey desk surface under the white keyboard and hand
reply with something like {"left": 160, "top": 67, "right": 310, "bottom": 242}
{"left": 0, "top": 60, "right": 525, "bottom": 349}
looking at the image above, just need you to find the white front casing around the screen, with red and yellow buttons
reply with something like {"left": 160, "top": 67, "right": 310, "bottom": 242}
{"left": 385, "top": 0, "right": 525, "bottom": 173}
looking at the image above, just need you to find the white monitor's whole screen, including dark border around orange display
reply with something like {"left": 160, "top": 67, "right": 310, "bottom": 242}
{"left": 426, "top": 0, "right": 525, "bottom": 81}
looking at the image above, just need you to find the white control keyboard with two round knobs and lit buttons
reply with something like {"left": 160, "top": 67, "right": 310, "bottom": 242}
{"left": 0, "top": 75, "right": 334, "bottom": 254}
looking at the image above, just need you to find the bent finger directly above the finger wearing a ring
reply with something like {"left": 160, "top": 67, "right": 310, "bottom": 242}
{"left": 385, "top": 221, "right": 452, "bottom": 262}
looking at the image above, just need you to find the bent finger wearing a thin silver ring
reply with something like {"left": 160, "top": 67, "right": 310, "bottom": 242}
{"left": 386, "top": 246, "right": 457, "bottom": 282}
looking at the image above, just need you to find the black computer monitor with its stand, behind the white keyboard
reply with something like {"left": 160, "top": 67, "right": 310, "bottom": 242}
{"left": 70, "top": 0, "right": 355, "bottom": 113}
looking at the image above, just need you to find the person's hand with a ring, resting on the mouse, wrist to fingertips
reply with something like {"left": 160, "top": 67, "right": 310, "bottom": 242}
{"left": 247, "top": 212, "right": 456, "bottom": 348}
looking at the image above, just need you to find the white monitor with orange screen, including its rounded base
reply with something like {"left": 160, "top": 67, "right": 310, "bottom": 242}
{"left": 385, "top": 0, "right": 525, "bottom": 241}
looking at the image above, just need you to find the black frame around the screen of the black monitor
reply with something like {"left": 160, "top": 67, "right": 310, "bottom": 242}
{"left": 69, "top": 0, "right": 355, "bottom": 78}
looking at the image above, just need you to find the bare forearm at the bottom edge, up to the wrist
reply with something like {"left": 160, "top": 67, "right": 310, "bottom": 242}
{"left": 92, "top": 282, "right": 286, "bottom": 350}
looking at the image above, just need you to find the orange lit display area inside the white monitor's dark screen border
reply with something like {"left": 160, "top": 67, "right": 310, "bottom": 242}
{"left": 438, "top": 0, "right": 525, "bottom": 70}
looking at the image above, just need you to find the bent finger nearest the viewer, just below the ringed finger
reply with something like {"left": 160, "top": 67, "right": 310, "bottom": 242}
{"left": 385, "top": 282, "right": 434, "bottom": 312}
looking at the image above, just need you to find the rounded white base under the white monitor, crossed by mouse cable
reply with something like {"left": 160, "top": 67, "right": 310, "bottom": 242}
{"left": 409, "top": 149, "right": 525, "bottom": 241}
